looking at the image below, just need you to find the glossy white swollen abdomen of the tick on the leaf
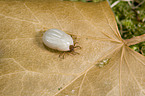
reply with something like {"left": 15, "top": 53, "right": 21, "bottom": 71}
{"left": 42, "top": 29, "right": 74, "bottom": 51}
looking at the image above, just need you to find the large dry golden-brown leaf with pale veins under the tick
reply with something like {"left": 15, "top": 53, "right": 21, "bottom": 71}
{"left": 0, "top": 0, "right": 145, "bottom": 96}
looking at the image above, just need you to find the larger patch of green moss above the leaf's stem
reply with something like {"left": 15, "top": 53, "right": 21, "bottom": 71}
{"left": 111, "top": 0, "right": 145, "bottom": 39}
